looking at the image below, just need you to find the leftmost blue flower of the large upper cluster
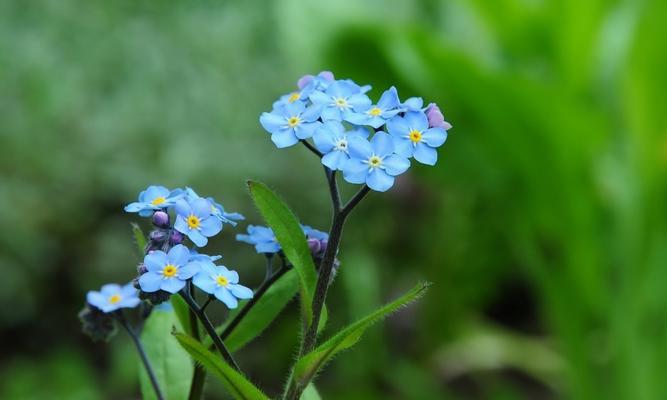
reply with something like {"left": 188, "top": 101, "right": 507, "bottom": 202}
{"left": 259, "top": 101, "right": 322, "bottom": 148}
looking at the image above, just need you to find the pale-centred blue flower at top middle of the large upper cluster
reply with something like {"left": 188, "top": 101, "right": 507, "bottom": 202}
{"left": 310, "top": 81, "right": 371, "bottom": 121}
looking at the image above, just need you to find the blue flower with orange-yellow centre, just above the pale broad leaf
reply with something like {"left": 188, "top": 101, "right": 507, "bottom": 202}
{"left": 139, "top": 244, "right": 200, "bottom": 294}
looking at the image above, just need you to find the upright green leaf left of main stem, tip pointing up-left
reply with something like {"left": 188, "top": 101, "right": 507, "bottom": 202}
{"left": 248, "top": 181, "right": 317, "bottom": 326}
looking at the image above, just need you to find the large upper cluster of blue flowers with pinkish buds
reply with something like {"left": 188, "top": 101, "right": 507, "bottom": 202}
{"left": 259, "top": 71, "right": 452, "bottom": 192}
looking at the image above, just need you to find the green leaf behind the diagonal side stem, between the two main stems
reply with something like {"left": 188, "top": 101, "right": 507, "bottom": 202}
{"left": 225, "top": 270, "right": 299, "bottom": 352}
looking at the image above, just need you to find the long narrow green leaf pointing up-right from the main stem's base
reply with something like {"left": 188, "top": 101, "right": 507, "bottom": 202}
{"left": 292, "top": 282, "right": 430, "bottom": 387}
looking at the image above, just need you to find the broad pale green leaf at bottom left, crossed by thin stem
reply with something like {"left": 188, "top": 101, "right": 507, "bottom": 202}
{"left": 139, "top": 308, "right": 193, "bottom": 400}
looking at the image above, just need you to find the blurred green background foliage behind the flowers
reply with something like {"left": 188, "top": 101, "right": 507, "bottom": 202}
{"left": 0, "top": 0, "right": 667, "bottom": 400}
